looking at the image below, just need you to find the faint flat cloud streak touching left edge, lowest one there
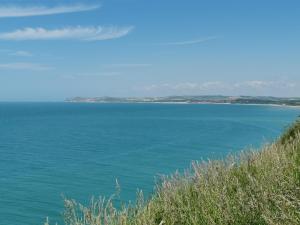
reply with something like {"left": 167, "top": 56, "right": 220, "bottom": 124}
{"left": 0, "top": 62, "right": 53, "bottom": 71}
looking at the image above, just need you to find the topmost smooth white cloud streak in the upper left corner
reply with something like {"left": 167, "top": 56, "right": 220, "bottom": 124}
{"left": 0, "top": 4, "right": 101, "bottom": 18}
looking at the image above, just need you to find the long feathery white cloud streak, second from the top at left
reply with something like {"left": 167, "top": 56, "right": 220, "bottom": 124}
{"left": 0, "top": 26, "right": 134, "bottom": 41}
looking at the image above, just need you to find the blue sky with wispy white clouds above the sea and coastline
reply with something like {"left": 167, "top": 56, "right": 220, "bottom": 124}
{"left": 0, "top": 0, "right": 300, "bottom": 101}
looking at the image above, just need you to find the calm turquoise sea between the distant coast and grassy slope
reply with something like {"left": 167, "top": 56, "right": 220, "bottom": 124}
{"left": 0, "top": 103, "right": 300, "bottom": 225}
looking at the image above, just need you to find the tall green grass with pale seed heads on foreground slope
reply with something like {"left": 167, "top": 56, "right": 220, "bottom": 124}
{"left": 45, "top": 121, "right": 300, "bottom": 225}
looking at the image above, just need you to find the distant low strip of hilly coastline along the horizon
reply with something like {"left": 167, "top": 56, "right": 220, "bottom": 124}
{"left": 66, "top": 95, "right": 300, "bottom": 106}
